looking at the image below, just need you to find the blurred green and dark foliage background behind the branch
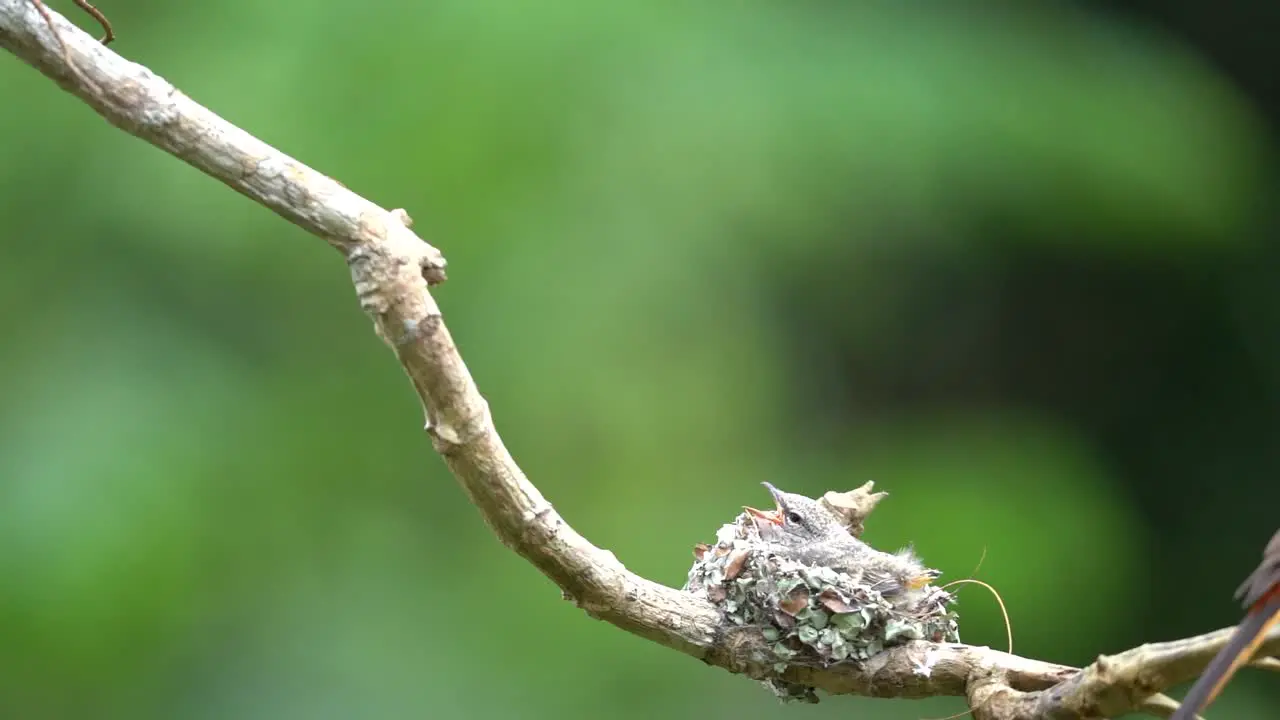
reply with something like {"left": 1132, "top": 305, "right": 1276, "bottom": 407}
{"left": 0, "top": 0, "right": 1280, "bottom": 720}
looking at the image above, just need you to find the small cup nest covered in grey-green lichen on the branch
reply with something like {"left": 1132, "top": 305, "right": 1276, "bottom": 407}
{"left": 684, "top": 483, "right": 960, "bottom": 702}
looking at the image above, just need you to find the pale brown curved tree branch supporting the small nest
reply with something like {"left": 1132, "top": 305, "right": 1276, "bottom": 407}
{"left": 0, "top": 0, "right": 1280, "bottom": 720}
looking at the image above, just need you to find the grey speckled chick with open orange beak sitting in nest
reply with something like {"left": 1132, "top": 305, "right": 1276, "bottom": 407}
{"left": 744, "top": 483, "right": 940, "bottom": 606}
